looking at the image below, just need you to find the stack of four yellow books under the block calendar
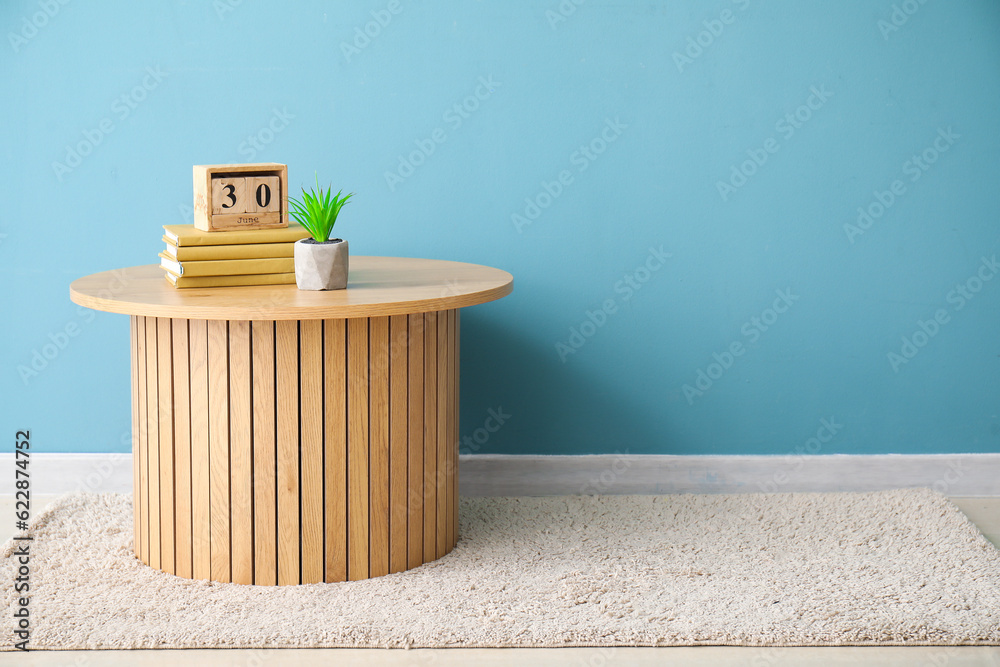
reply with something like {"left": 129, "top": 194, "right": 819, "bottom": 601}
{"left": 160, "top": 223, "right": 309, "bottom": 287}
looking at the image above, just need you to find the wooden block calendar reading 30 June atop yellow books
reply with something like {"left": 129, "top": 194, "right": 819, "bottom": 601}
{"left": 194, "top": 162, "right": 288, "bottom": 232}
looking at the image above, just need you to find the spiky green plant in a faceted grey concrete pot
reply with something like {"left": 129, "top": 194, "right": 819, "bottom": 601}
{"left": 288, "top": 176, "right": 354, "bottom": 290}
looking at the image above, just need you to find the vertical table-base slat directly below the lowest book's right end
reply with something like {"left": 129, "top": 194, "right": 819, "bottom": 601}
{"left": 274, "top": 320, "right": 301, "bottom": 586}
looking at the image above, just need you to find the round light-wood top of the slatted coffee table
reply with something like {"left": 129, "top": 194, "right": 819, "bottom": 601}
{"left": 69, "top": 256, "right": 514, "bottom": 320}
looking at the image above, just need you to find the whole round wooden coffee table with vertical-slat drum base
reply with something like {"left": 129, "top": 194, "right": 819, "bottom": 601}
{"left": 70, "top": 257, "right": 513, "bottom": 585}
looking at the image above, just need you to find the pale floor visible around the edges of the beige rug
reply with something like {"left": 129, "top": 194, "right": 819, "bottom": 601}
{"left": 0, "top": 496, "right": 1000, "bottom": 667}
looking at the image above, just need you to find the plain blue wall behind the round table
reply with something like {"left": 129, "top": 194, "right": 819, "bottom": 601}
{"left": 0, "top": 0, "right": 1000, "bottom": 454}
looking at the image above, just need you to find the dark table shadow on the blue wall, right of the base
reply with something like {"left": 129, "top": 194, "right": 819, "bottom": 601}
{"left": 459, "top": 308, "right": 673, "bottom": 454}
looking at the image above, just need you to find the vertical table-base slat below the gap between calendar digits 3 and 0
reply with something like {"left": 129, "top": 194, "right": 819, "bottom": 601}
{"left": 229, "top": 320, "right": 253, "bottom": 584}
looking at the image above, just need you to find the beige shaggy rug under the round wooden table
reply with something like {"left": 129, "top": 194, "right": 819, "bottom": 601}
{"left": 0, "top": 489, "right": 1000, "bottom": 649}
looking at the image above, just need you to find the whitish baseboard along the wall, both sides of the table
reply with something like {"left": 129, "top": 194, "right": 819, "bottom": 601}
{"left": 0, "top": 453, "right": 1000, "bottom": 496}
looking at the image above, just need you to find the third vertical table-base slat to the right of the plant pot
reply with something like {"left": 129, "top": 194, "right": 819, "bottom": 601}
{"left": 389, "top": 315, "right": 408, "bottom": 572}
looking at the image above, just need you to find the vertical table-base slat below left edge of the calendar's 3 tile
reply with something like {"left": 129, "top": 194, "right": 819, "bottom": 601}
{"left": 208, "top": 320, "right": 232, "bottom": 582}
